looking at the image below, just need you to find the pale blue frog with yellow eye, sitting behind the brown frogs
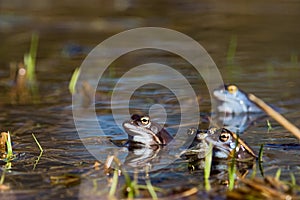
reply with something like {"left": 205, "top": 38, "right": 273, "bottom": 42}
{"left": 213, "top": 84, "right": 263, "bottom": 114}
